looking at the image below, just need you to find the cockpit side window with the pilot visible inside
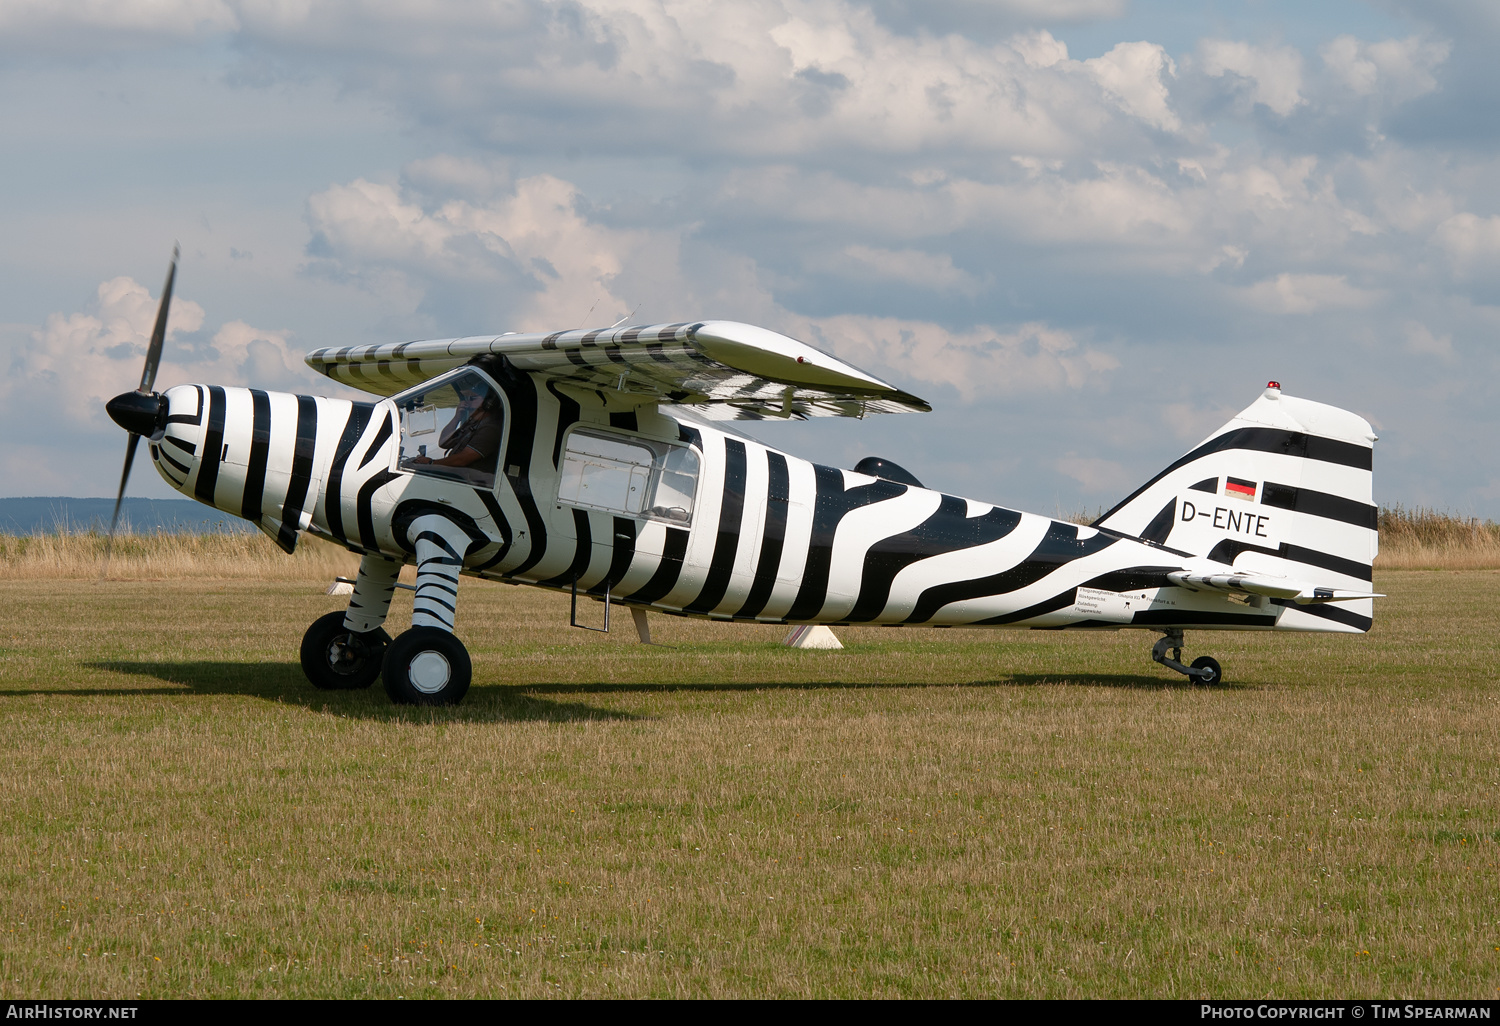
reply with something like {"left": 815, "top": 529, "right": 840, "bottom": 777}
{"left": 396, "top": 371, "right": 506, "bottom": 488}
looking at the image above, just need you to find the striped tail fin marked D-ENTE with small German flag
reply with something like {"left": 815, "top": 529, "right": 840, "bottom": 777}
{"left": 1094, "top": 383, "right": 1380, "bottom": 630}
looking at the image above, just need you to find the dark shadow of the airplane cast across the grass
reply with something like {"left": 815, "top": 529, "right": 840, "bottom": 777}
{"left": 61, "top": 660, "right": 1244, "bottom": 723}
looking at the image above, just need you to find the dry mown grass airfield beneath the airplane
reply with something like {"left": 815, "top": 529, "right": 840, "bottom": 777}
{"left": 0, "top": 570, "right": 1500, "bottom": 999}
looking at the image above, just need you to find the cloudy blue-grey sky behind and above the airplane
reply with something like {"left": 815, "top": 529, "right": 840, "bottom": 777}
{"left": 0, "top": 0, "right": 1500, "bottom": 519}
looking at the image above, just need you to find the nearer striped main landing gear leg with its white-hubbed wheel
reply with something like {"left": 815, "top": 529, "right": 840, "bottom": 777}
{"left": 381, "top": 513, "right": 473, "bottom": 705}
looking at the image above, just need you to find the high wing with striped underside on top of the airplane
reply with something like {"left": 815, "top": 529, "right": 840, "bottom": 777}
{"left": 306, "top": 321, "right": 932, "bottom": 420}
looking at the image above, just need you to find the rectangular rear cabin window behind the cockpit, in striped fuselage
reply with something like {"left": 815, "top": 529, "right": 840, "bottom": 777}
{"left": 558, "top": 429, "right": 698, "bottom": 524}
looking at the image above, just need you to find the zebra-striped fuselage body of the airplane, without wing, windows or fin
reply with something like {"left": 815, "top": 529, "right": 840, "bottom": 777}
{"left": 152, "top": 368, "right": 1349, "bottom": 630}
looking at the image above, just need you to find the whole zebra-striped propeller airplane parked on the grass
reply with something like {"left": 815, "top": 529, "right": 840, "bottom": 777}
{"left": 107, "top": 252, "right": 1382, "bottom": 705}
